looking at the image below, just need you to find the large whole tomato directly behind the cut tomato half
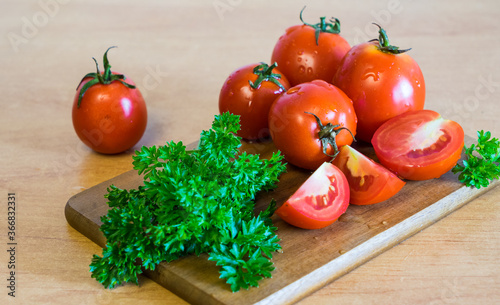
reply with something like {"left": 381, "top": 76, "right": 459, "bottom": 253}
{"left": 332, "top": 24, "right": 425, "bottom": 142}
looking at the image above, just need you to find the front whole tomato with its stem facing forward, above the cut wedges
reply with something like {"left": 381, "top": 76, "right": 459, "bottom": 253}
{"left": 269, "top": 80, "right": 357, "bottom": 170}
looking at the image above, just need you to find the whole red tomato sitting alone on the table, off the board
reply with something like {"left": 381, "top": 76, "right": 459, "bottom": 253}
{"left": 72, "top": 47, "right": 147, "bottom": 154}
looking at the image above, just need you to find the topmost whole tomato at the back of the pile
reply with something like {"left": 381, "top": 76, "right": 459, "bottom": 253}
{"left": 271, "top": 10, "right": 351, "bottom": 86}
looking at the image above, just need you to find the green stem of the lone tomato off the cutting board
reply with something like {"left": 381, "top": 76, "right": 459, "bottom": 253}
{"left": 76, "top": 46, "right": 135, "bottom": 108}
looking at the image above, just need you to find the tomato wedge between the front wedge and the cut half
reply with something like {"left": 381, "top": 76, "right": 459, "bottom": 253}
{"left": 332, "top": 145, "right": 406, "bottom": 205}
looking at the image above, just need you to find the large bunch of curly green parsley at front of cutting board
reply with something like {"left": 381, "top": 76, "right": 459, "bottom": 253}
{"left": 90, "top": 113, "right": 285, "bottom": 291}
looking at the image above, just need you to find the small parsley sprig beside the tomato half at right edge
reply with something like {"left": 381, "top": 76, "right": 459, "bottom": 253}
{"left": 452, "top": 130, "right": 500, "bottom": 188}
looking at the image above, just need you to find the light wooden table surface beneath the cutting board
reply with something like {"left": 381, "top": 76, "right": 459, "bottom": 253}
{"left": 0, "top": 0, "right": 500, "bottom": 305}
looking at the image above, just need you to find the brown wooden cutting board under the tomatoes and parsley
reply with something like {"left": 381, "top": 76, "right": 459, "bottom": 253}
{"left": 65, "top": 137, "right": 498, "bottom": 305}
